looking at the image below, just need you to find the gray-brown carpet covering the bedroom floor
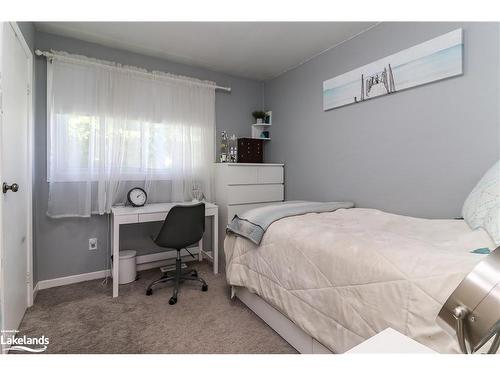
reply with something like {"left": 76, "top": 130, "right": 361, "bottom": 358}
{"left": 19, "top": 263, "right": 296, "bottom": 353}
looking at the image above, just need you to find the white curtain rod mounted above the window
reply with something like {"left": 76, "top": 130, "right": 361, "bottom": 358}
{"left": 35, "top": 49, "right": 231, "bottom": 92}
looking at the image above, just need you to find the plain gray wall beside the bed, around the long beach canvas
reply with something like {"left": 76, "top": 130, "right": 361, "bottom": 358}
{"left": 264, "top": 22, "right": 500, "bottom": 218}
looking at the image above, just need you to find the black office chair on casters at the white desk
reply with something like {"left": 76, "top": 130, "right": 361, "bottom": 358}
{"left": 146, "top": 203, "right": 208, "bottom": 305}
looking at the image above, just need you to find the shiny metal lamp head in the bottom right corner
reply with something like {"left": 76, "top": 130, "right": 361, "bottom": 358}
{"left": 436, "top": 247, "right": 500, "bottom": 354}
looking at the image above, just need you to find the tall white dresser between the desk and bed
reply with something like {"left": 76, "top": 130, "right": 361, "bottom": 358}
{"left": 215, "top": 163, "right": 285, "bottom": 258}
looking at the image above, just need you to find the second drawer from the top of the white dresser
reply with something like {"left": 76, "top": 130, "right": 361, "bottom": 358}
{"left": 227, "top": 184, "right": 283, "bottom": 204}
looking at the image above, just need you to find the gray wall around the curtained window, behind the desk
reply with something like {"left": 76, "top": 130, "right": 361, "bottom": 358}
{"left": 34, "top": 32, "right": 262, "bottom": 280}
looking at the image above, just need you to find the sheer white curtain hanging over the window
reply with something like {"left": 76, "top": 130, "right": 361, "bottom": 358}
{"left": 47, "top": 55, "right": 215, "bottom": 217}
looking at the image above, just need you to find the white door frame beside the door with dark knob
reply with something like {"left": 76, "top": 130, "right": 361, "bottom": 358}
{"left": 0, "top": 22, "right": 34, "bottom": 340}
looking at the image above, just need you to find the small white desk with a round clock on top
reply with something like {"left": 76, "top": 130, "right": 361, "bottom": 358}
{"left": 111, "top": 202, "right": 219, "bottom": 297}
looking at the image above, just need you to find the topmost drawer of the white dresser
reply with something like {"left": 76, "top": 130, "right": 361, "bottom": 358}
{"left": 226, "top": 165, "right": 283, "bottom": 185}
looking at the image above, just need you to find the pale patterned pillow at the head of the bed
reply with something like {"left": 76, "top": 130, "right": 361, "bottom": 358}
{"left": 462, "top": 161, "right": 500, "bottom": 245}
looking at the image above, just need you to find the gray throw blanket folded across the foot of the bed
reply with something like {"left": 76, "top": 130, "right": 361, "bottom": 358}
{"left": 226, "top": 201, "right": 354, "bottom": 245}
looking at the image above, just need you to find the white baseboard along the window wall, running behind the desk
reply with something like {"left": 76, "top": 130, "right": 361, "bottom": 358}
{"left": 37, "top": 248, "right": 198, "bottom": 290}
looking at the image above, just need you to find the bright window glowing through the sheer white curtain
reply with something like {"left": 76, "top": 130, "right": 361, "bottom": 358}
{"left": 49, "top": 114, "right": 202, "bottom": 182}
